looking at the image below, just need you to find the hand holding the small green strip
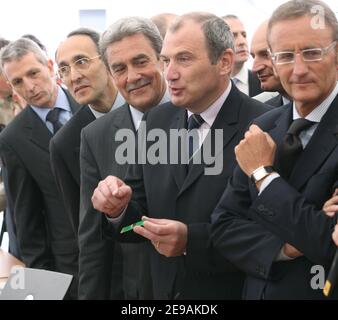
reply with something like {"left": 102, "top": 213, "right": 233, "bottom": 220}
{"left": 134, "top": 217, "right": 188, "bottom": 257}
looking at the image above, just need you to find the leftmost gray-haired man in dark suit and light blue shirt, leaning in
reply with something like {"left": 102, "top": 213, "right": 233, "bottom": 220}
{"left": 0, "top": 39, "right": 79, "bottom": 297}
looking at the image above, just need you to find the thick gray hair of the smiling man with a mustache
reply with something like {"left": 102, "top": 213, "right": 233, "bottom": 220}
{"left": 99, "top": 17, "right": 163, "bottom": 68}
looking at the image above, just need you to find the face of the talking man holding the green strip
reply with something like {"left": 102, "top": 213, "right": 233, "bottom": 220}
{"left": 161, "top": 20, "right": 233, "bottom": 113}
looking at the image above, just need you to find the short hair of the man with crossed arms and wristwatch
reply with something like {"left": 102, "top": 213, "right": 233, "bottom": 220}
{"left": 268, "top": 0, "right": 338, "bottom": 45}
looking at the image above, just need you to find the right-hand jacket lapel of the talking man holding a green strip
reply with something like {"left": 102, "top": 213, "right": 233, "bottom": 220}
{"left": 180, "top": 85, "right": 243, "bottom": 194}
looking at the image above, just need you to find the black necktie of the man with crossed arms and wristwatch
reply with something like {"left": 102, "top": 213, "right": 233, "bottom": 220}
{"left": 280, "top": 118, "right": 314, "bottom": 179}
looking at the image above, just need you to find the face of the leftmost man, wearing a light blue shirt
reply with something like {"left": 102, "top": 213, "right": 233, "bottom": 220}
{"left": 3, "top": 52, "right": 57, "bottom": 108}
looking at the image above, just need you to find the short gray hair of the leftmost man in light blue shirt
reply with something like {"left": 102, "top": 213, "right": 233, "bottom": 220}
{"left": 0, "top": 38, "right": 48, "bottom": 69}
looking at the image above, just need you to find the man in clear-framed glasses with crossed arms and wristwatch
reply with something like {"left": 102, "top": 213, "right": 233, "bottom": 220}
{"left": 212, "top": 0, "right": 338, "bottom": 299}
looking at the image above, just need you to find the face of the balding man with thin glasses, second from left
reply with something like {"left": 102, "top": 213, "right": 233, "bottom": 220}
{"left": 56, "top": 35, "right": 111, "bottom": 105}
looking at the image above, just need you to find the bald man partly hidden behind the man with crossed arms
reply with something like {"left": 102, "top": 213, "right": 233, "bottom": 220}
{"left": 250, "top": 21, "right": 291, "bottom": 107}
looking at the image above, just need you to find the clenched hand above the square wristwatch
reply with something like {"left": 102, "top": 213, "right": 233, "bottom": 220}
{"left": 235, "top": 125, "right": 276, "bottom": 177}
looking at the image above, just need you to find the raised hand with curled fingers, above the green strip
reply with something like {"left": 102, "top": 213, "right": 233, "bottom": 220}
{"left": 92, "top": 176, "right": 132, "bottom": 218}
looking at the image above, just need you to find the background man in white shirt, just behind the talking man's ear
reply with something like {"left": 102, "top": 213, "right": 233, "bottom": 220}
{"left": 222, "top": 14, "right": 262, "bottom": 97}
